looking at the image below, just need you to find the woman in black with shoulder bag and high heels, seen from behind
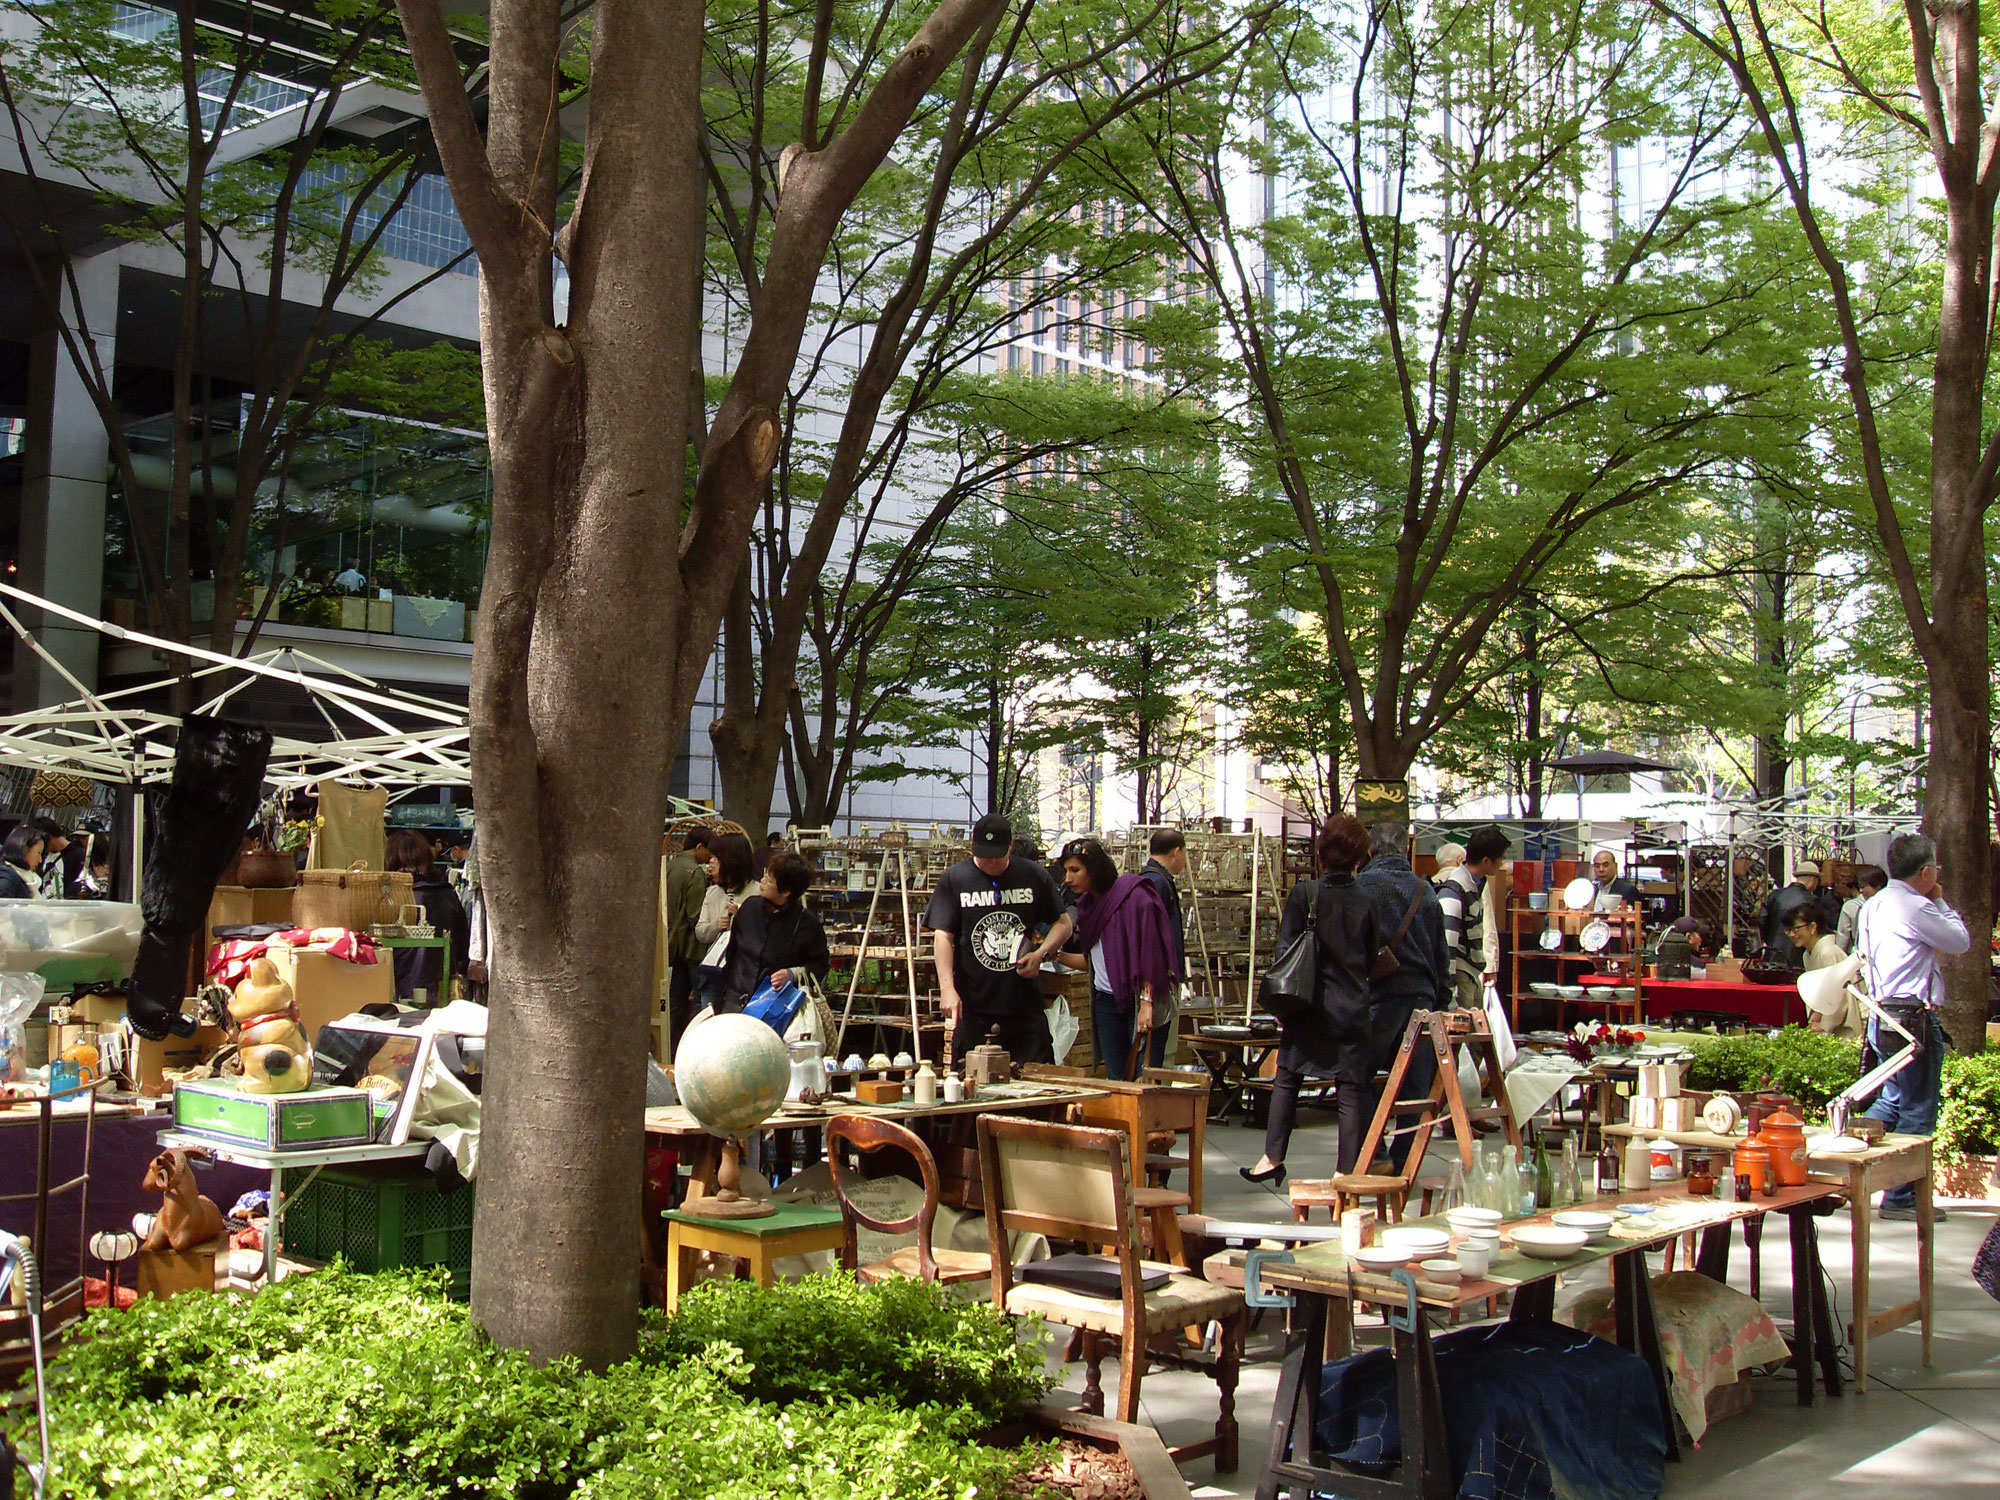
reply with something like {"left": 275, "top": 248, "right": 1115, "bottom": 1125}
{"left": 1238, "top": 814, "right": 1382, "bottom": 1188}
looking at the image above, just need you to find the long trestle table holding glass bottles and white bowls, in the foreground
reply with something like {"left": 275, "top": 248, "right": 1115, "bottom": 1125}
{"left": 1258, "top": 1182, "right": 1842, "bottom": 1500}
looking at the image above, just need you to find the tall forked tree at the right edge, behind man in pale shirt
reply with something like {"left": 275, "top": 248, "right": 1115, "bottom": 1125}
{"left": 1654, "top": 0, "right": 2000, "bottom": 1050}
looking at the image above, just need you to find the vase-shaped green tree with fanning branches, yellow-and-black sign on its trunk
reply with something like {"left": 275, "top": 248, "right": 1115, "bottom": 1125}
{"left": 1104, "top": 0, "right": 1808, "bottom": 776}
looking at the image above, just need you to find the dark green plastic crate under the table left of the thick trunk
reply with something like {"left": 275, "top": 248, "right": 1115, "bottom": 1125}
{"left": 284, "top": 1162, "right": 474, "bottom": 1302}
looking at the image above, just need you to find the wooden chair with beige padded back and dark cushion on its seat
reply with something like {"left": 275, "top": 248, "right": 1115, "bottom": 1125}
{"left": 978, "top": 1114, "right": 1246, "bottom": 1474}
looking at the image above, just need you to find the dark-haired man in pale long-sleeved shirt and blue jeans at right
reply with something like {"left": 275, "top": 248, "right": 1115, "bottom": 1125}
{"left": 1860, "top": 834, "right": 1972, "bottom": 1218}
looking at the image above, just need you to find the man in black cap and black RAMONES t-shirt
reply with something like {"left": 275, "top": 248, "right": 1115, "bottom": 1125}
{"left": 924, "top": 812, "right": 1072, "bottom": 1062}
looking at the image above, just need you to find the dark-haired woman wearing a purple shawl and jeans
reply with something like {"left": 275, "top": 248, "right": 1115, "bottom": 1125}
{"left": 1060, "top": 838, "right": 1174, "bottom": 1078}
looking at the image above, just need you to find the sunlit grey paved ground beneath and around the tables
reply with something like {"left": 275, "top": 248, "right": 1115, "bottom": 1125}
{"left": 1064, "top": 1110, "right": 2000, "bottom": 1500}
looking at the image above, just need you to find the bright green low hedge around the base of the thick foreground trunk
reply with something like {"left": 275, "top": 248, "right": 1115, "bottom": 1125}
{"left": 18, "top": 1266, "right": 1048, "bottom": 1500}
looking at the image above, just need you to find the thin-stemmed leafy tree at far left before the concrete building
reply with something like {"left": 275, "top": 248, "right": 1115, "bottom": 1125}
{"left": 0, "top": 0, "right": 458, "bottom": 698}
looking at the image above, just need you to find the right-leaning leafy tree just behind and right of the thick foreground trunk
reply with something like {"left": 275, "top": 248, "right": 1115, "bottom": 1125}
{"left": 704, "top": 0, "right": 1268, "bottom": 826}
